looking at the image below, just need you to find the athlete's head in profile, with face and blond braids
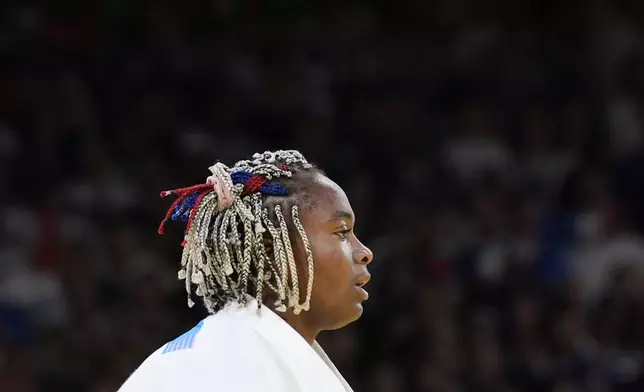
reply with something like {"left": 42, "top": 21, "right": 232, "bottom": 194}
{"left": 159, "top": 150, "right": 373, "bottom": 330}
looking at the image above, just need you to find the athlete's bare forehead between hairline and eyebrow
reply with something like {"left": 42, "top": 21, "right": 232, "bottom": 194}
{"left": 307, "top": 175, "right": 353, "bottom": 221}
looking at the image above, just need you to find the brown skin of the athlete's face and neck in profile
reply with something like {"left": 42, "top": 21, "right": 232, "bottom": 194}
{"left": 277, "top": 175, "right": 373, "bottom": 343}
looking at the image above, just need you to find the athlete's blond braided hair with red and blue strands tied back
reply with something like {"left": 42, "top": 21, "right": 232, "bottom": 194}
{"left": 159, "top": 150, "right": 324, "bottom": 314}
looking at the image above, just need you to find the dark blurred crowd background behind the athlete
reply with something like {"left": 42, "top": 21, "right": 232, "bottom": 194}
{"left": 0, "top": 0, "right": 644, "bottom": 392}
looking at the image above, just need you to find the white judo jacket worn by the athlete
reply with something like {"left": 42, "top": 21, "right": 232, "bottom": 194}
{"left": 119, "top": 301, "right": 352, "bottom": 392}
